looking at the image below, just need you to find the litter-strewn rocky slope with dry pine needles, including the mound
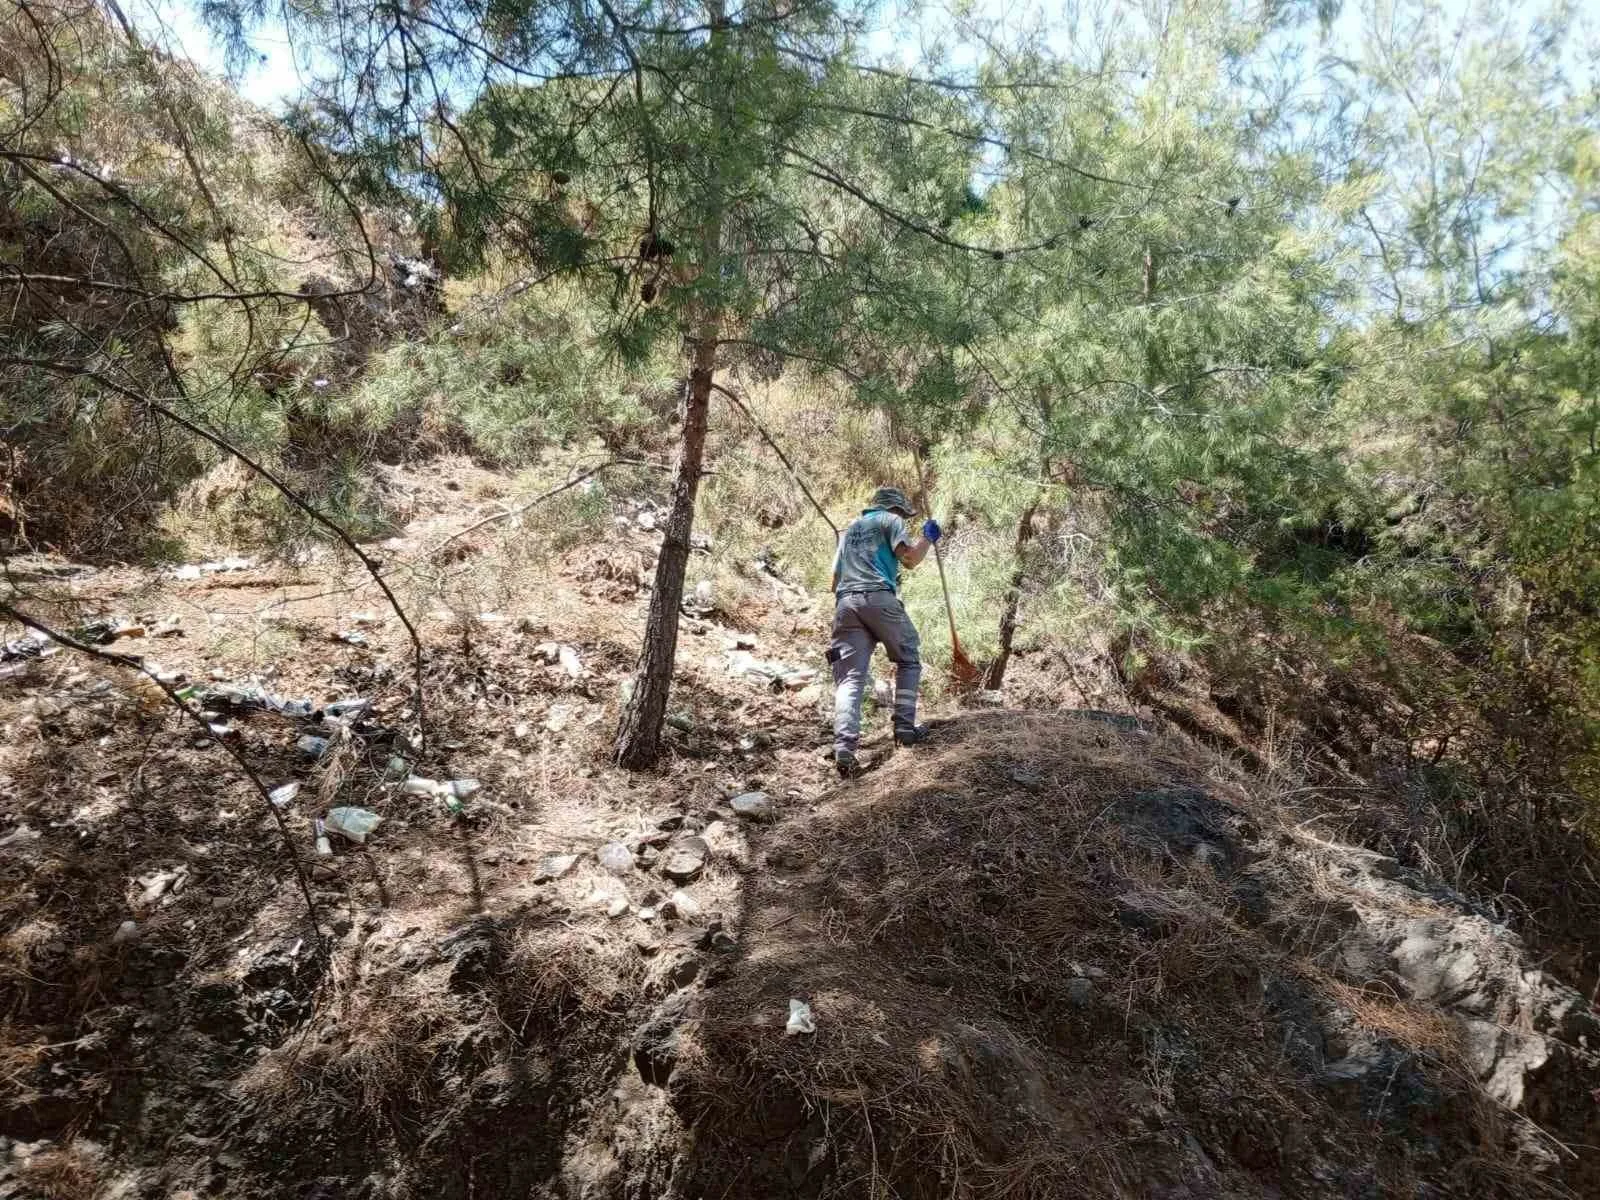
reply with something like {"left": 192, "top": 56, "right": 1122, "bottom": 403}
{"left": 0, "top": 478, "right": 1600, "bottom": 1200}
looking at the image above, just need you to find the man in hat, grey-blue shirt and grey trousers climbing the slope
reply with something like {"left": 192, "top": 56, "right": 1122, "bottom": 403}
{"left": 827, "top": 488, "right": 939, "bottom": 779}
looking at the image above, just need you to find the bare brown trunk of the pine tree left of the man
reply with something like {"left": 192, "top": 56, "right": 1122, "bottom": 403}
{"left": 616, "top": 339, "right": 717, "bottom": 770}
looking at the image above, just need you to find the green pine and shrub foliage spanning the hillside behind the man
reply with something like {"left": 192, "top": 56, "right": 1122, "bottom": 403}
{"left": 9, "top": 0, "right": 1600, "bottom": 844}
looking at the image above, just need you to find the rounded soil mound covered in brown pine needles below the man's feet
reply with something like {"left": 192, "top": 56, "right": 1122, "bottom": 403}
{"left": 658, "top": 714, "right": 1600, "bottom": 1197}
